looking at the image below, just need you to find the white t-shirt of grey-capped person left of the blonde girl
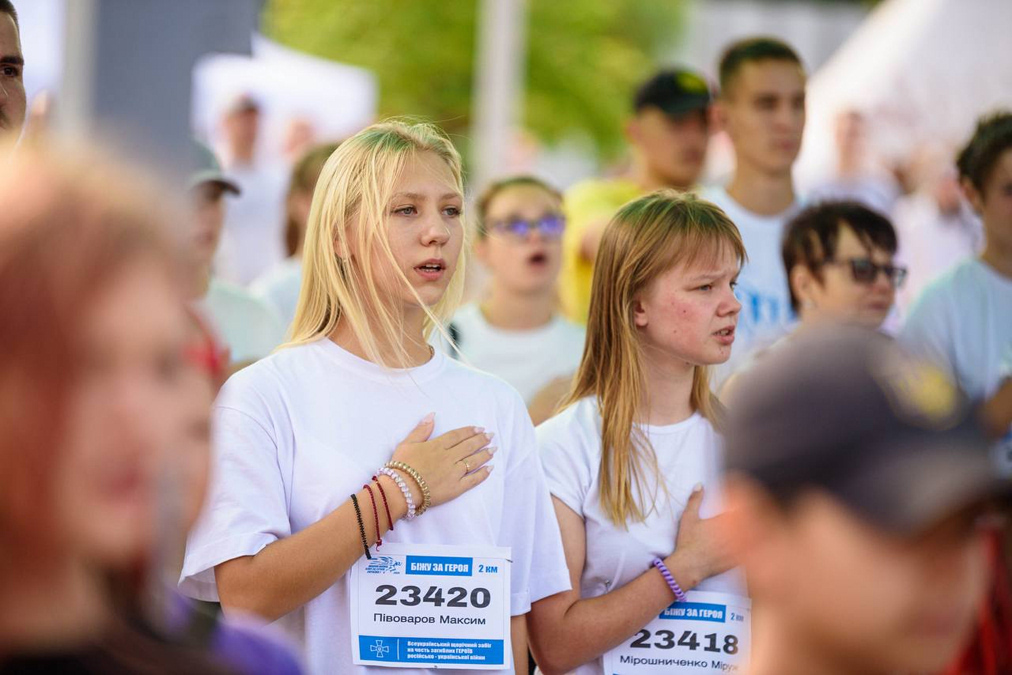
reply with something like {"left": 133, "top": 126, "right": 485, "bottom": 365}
{"left": 196, "top": 277, "right": 284, "bottom": 363}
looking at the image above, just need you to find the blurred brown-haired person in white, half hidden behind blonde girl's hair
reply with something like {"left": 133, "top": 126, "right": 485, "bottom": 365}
{"left": 250, "top": 143, "right": 337, "bottom": 327}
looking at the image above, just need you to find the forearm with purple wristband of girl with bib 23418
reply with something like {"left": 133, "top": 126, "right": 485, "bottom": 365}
{"left": 528, "top": 555, "right": 699, "bottom": 675}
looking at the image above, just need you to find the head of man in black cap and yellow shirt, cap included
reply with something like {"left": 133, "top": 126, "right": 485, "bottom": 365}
{"left": 626, "top": 69, "right": 710, "bottom": 189}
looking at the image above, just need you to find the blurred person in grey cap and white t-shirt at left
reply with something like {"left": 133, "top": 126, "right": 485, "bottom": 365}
{"left": 183, "top": 142, "right": 284, "bottom": 372}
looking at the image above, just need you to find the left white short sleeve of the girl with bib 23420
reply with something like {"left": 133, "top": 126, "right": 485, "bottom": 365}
{"left": 179, "top": 374, "right": 291, "bottom": 601}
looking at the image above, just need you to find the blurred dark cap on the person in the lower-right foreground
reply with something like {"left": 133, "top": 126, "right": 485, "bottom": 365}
{"left": 726, "top": 325, "right": 1012, "bottom": 535}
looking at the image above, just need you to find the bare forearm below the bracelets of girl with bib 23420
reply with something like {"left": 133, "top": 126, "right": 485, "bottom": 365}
{"left": 215, "top": 476, "right": 407, "bottom": 620}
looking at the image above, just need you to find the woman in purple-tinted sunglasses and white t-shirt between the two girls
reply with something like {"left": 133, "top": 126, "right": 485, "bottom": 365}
{"left": 445, "top": 176, "right": 584, "bottom": 424}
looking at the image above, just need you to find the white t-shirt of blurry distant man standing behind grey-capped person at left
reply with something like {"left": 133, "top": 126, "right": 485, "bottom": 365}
{"left": 215, "top": 165, "right": 287, "bottom": 286}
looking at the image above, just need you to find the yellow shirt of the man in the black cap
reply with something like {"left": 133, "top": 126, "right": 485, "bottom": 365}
{"left": 559, "top": 179, "right": 644, "bottom": 326}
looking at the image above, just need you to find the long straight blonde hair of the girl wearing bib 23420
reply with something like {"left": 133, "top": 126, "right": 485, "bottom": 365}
{"left": 285, "top": 120, "right": 467, "bottom": 367}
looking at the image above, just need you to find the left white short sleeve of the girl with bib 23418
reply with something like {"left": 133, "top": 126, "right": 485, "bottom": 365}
{"left": 537, "top": 411, "right": 593, "bottom": 516}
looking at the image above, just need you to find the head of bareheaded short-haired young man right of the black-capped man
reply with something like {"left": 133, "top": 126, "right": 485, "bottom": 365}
{"left": 718, "top": 37, "right": 806, "bottom": 174}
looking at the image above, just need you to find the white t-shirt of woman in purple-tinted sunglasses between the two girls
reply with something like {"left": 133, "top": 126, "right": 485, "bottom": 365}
{"left": 438, "top": 303, "right": 585, "bottom": 403}
